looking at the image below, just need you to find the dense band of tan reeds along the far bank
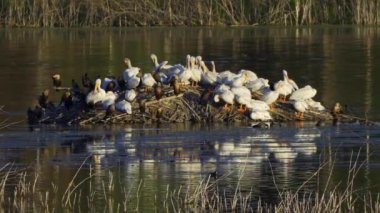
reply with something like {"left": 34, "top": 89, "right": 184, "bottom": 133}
{"left": 0, "top": 0, "right": 380, "bottom": 27}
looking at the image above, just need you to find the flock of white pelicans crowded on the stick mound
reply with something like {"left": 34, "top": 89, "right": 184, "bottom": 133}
{"left": 35, "top": 54, "right": 326, "bottom": 125}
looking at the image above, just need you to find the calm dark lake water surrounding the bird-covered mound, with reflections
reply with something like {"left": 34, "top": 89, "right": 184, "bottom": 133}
{"left": 0, "top": 26, "right": 380, "bottom": 211}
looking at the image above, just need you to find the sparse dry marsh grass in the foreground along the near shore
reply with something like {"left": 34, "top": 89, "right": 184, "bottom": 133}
{"left": 0, "top": 149, "right": 380, "bottom": 212}
